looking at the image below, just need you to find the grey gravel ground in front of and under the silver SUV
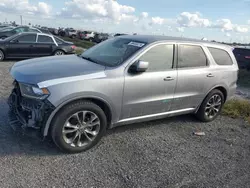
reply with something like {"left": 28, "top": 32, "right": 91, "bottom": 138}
{"left": 0, "top": 61, "right": 250, "bottom": 188}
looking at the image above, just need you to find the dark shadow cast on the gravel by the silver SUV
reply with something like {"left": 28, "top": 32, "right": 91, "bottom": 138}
{"left": 0, "top": 98, "right": 201, "bottom": 158}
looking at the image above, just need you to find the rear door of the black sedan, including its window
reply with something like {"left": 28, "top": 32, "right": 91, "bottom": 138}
{"left": 35, "top": 34, "right": 55, "bottom": 57}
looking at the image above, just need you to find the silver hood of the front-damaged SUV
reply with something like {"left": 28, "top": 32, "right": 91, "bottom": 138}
{"left": 10, "top": 55, "right": 105, "bottom": 84}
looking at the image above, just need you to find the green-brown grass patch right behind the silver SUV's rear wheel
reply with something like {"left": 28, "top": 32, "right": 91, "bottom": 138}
{"left": 222, "top": 99, "right": 250, "bottom": 123}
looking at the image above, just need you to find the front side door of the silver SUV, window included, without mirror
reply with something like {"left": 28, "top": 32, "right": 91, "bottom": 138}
{"left": 121, "top": 44, "right": 177, "bottom": 119}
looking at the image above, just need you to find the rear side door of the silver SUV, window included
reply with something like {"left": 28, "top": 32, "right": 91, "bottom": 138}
{"left": 171, "top": 44, "right": 216, "bottom": 110}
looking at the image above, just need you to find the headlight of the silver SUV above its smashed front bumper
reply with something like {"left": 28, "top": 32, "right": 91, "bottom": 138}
{"left": 19, "top": 83, "right": 50, "bottom": 99}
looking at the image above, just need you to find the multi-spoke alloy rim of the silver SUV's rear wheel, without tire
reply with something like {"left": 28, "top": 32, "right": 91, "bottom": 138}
{"left": 205, "top": 94, "right": 222, "bottom": 119}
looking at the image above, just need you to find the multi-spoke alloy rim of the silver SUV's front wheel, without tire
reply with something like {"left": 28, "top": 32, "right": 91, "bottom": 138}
{"left": 62, "top": 111, "right": 101, "bottom": 147}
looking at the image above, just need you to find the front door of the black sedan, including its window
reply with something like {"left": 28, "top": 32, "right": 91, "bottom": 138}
{"left": 6, "top": 34, "right": 36, "bottom": 57}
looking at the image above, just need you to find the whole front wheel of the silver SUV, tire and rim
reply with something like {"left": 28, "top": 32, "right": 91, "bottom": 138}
{"left": 51, "top": 101, "right": 107, "bottom": 153}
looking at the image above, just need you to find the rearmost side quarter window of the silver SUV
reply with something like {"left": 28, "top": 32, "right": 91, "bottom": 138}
{"left": 208, "top": 47, "right": 233, "bottom": 65}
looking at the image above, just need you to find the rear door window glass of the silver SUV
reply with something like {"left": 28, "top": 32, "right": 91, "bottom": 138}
{"left": 178, "top": 44, "right": 207, "bottom": 68}
